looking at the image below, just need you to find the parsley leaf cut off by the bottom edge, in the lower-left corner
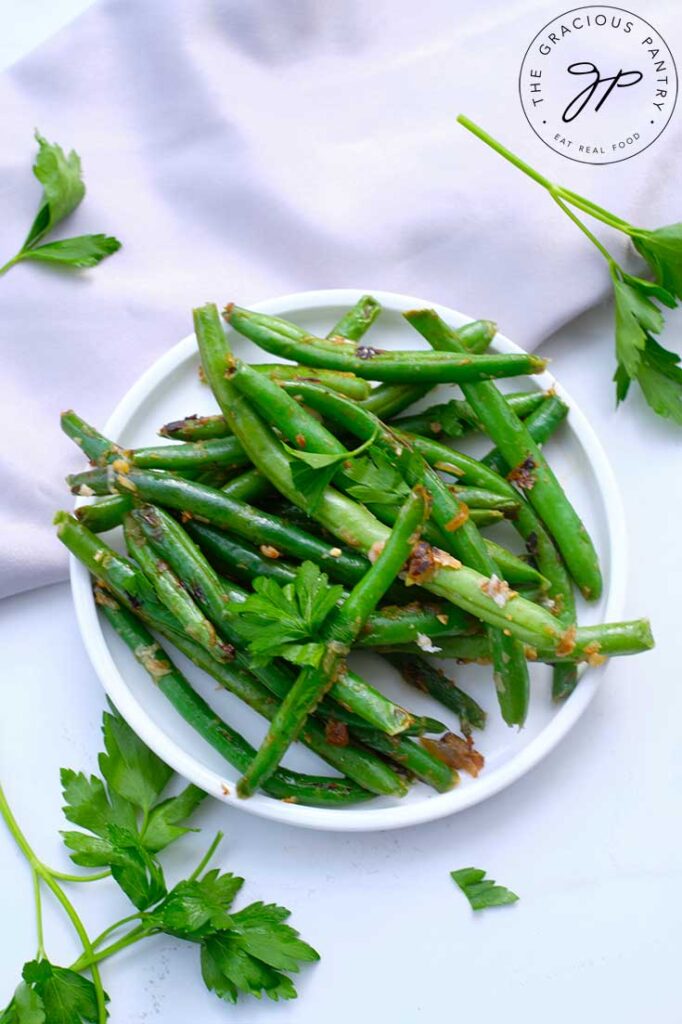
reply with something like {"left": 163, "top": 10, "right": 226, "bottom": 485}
{"left": 16, "top": 959, "right": 106, "bottom": 1024}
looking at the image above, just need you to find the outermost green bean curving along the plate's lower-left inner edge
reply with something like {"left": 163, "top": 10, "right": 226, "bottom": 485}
{"left": 96, "top": 589, "right": 379, "bottom": 807}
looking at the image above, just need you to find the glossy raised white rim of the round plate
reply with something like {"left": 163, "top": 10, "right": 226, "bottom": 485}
{"left": 70, "top": 288, "right": 628, "bottom": 831}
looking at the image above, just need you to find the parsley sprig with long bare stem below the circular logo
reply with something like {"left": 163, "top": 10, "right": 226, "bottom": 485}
{"left": 458, "top": 115, "right": 682, "bottom": 425}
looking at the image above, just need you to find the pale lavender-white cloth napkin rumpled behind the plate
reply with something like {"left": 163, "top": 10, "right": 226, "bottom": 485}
{"left": 0, "top": 0, "right": 682, "bottom": 596}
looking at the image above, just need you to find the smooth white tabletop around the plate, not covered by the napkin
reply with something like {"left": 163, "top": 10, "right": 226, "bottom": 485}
{"left": 0, "top": 0, "right": 682, "bottom": 1024}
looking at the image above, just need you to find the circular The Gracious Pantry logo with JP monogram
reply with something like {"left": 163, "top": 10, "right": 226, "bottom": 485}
{"left": 518, "top": 4, "right": 677, "bottom": 164}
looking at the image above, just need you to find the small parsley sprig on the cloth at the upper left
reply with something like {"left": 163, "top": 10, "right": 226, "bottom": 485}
{"left": 0, "top": 132, "right": 121, "bottom": 274}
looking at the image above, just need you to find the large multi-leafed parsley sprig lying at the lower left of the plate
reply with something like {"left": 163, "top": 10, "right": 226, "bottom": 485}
{"left": 0, "top": 713, "right": 319, "bottom": 1024}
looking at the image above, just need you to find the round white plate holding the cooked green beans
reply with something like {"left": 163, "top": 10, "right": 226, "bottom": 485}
{"left": 71, "top": 290, "right": 626, "bottom": 831}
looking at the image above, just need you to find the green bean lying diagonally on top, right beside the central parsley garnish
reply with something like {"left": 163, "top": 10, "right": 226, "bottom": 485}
{"left": 237, "top": 492, "right": 428, "bottom": 798}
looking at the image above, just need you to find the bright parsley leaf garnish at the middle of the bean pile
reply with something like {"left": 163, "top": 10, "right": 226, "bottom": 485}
{"left": 235, "top": 562, "right": 343, "bottom": 666}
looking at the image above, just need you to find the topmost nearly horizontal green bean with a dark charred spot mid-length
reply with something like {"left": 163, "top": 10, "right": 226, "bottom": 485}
{"left": 225, "top": 305, "right": 546, "bottom": 384}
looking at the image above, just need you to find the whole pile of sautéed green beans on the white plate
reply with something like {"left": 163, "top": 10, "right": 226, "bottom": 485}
{"left": 55, "top": 296, "right": 653, "bottom": 808}
